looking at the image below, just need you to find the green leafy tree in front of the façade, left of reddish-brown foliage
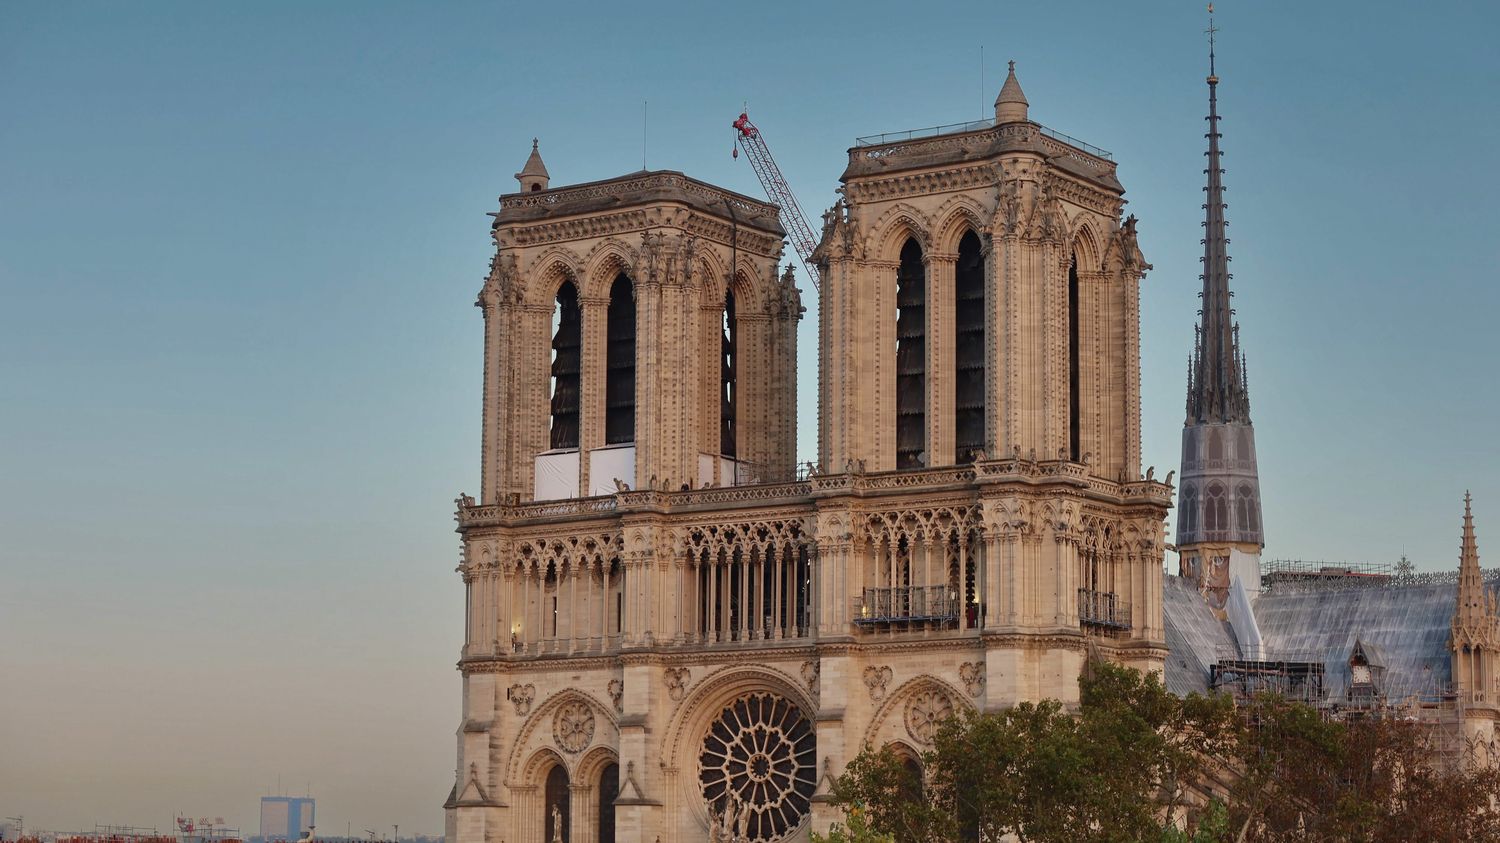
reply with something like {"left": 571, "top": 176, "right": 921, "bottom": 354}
{"left": 834, "top": 663, "right": 1235, "bottom": 843}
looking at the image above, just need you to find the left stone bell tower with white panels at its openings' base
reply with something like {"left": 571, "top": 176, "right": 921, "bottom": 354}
{"left": 477, "top": 141, "right": 801, "bottom": 503}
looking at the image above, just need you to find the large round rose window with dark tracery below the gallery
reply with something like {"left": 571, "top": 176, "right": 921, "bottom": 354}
{"left": 698, "top": 693, "right": 818, "bottom": 843}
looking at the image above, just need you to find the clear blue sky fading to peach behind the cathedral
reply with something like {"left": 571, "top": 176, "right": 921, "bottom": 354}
{"left": 0, "top": 0, "right": 1500, "bottom": 833}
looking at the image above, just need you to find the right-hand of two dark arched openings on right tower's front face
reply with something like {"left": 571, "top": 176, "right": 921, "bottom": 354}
{"left": 953, "top": 231, "right": 986, "bottom": 464}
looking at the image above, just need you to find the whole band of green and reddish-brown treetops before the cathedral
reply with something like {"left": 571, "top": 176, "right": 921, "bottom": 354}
{"left": 813, "top": 663, "right": 1500, "bottom": 843}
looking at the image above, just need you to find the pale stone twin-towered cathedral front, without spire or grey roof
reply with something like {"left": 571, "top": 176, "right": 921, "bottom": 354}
{"left": 447, "top": 62, "right": 1172, "bottom": 843}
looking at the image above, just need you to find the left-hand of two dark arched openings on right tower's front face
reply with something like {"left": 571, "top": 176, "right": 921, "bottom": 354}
{"left": 896, "top": 239, "right": 927, "bottom": 468}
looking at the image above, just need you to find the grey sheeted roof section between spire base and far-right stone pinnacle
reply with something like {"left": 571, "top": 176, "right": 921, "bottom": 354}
{"left": 1256, "top": 584, "right": 1458, "bottom": 702}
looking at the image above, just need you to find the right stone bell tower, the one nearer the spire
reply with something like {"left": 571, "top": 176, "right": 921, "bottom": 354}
{"left": 819, "top": 63, "right": 1151, "bottom": 480}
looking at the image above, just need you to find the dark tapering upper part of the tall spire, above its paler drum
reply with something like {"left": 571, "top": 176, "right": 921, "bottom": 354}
{"left": 1188, "top": 6, "right": 1250, "bottom": 425}
